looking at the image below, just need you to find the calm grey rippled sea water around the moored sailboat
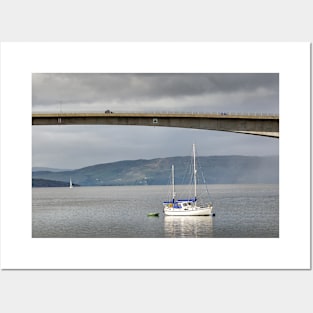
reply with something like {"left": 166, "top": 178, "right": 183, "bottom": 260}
{"left": 32, "top": 185, "right": 279, "bottom": 238}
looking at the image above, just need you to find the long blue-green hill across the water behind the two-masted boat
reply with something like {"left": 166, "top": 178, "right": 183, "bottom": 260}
{"left": 33, "top": 156, "right": 279, "bottom": 186}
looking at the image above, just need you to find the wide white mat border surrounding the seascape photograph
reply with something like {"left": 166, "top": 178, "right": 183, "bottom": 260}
{"left": 1, "top": 43, "right": 310, "bottom": 269}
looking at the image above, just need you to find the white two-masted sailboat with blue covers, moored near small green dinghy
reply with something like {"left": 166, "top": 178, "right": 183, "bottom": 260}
{"left": 163, "top": 144, "right": 215, "bottom": 216}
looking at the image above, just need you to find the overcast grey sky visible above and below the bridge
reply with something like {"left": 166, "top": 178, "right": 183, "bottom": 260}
{"left": 32, "top": 73, "right": 279, "bottom": 169}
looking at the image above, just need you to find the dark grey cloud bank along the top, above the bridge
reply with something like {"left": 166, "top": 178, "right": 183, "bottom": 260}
{"left": 33, "top": 73, "right": 278, "bottom": 111}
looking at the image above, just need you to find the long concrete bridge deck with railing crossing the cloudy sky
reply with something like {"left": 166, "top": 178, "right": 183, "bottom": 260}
{"left": 32, "top": 111, "right": 279, "bottom": 138}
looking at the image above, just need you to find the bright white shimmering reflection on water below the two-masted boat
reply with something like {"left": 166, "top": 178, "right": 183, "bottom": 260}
{"left": 164, "top": 216, "right": 213, "bottom": 238}
